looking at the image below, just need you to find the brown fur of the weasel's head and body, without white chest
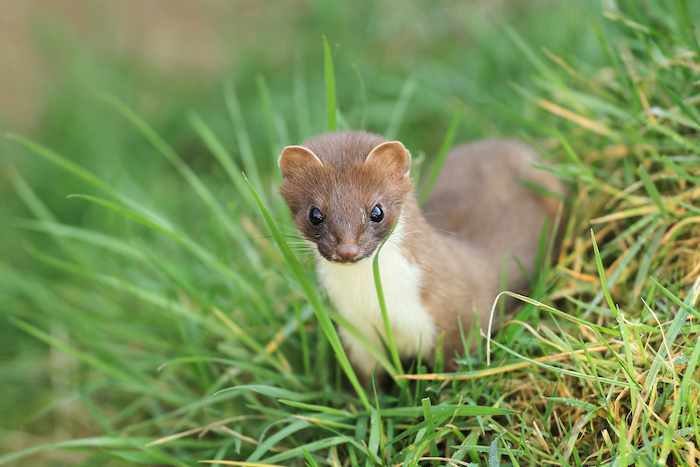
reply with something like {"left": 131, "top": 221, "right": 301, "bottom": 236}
{"left": 280, "top": 132, "right": 564, "bottom": 370}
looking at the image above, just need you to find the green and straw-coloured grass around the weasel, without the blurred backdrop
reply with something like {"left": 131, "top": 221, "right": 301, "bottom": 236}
{"left": 0, "top": 0, "right": 700, "bottom": 466}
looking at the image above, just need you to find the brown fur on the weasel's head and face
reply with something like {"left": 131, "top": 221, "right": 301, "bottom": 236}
{"left": 279, "top": 132, "right": 413, "bottom": 260}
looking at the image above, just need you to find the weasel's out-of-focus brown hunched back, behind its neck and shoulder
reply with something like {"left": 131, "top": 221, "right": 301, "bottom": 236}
{"left": 423, "top": 140, "right": 565, "bottom": 290}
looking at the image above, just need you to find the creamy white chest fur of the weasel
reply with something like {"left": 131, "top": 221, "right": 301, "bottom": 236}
{"left": 317, "top": 221, "right": 438, "bottom": 374}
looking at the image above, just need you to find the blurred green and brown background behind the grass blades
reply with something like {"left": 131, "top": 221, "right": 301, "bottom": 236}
{"left": 0, "top": 0, "right": 680, "bottom": 462}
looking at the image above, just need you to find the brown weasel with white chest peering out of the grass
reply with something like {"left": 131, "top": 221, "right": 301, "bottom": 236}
{"left": 279, "top": 131, "right": 564, "bottom": 380}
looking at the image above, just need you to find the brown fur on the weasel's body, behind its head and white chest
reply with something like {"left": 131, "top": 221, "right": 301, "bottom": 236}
{"left": 418, "top": 140, "right": 565, "bottom": 369}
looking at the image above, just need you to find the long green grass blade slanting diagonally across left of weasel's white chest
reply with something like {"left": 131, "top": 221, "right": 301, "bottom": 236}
{"left": 246, "top": 174, "right": 370, "bottom": 411}
